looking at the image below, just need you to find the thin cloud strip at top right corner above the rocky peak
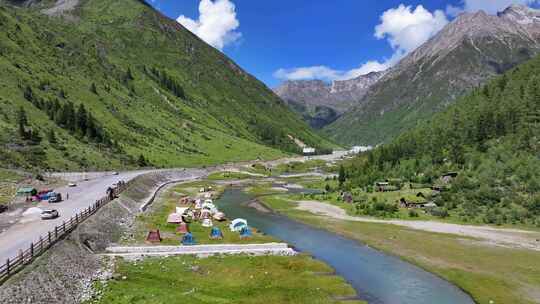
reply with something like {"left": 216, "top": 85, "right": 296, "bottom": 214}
{"left": 446, "top": 0, "right": 540, "bottom": 17}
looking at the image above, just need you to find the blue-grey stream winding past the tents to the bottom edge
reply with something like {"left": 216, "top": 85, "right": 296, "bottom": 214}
{"left": 217, "top": 189, "right": 474, "bottom": 304}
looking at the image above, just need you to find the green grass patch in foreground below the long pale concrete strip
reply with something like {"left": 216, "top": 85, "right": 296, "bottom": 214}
{"left": 87, "top": 255, "right": 361, "bottom": 304}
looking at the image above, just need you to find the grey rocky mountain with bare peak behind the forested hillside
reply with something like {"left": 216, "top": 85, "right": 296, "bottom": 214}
{"left": 325, "top": 5, "right": 540, "bottom": 145}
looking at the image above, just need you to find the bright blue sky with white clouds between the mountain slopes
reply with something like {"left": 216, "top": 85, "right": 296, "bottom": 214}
{"left": 150, "top": 0, "right": 540, "bottom": 87}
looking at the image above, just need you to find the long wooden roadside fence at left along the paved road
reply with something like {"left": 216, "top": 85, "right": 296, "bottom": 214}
{"left": 0, "top": 182, "right": 128, "bottom": 284}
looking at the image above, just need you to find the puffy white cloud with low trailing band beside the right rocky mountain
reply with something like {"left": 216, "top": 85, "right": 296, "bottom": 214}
{"left": 274, "top": 4, "right": 448, "bottom": 81}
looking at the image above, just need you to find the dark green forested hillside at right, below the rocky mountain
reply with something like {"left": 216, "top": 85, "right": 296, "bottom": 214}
{"left": 346, "top": 57, "right": 540, "bottom": 226}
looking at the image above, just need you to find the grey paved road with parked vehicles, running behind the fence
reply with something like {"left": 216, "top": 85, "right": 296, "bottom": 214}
{"left": 0, "top": 153, "right": 344, "bottom": 264}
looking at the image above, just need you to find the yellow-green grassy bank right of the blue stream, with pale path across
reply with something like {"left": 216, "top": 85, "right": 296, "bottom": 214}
{"left": 261, "top": 197, "right": 540, "bottom": 304}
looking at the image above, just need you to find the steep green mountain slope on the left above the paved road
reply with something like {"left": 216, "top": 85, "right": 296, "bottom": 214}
{"left": 0, "top": 0, "right": 331, "bottom": 169}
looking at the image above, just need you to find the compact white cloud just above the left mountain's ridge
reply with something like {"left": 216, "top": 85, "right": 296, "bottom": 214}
{"left": 176, "top": 0, "right": 242, "bottom": 50}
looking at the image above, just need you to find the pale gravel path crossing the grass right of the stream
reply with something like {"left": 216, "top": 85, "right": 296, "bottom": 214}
{"left": 297, "top": 201, "right": 540, "bottom": 251}
